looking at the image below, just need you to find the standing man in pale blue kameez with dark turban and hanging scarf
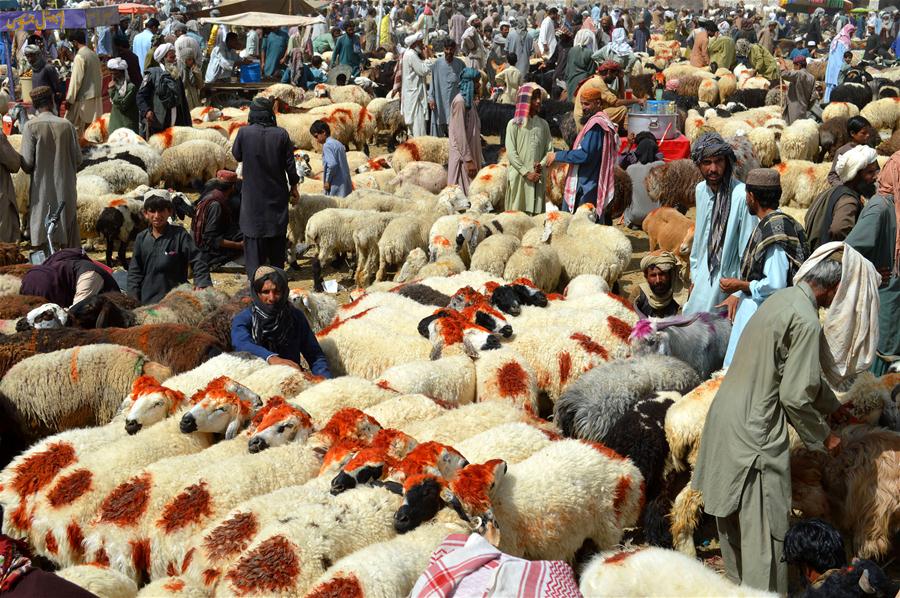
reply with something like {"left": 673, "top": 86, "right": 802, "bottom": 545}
{"left": 683, "top": 133, "right": 757, "bottom": 315}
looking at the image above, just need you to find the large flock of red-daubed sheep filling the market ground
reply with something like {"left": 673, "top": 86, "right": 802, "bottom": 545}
{"left": 0, "top": 36, "right": 900, "bottom": 597}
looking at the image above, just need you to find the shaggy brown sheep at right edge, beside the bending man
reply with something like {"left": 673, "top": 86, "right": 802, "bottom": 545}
{"left": 791, "top": 425, "right": 900, "bottom": 559}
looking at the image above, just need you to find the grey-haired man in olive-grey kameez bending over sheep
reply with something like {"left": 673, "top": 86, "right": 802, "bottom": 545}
{"left": 693, "top": 253, "right": 841, "bottom": 595}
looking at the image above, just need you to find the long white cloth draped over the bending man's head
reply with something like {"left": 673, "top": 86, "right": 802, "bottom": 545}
{"left": 794, "top": 241, "right": 881, "bottom": 386}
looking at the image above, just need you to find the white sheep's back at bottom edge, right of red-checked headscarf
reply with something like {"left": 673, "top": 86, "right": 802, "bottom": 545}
{"left": 579, "top": 547, "right": 776, "bottom": 598}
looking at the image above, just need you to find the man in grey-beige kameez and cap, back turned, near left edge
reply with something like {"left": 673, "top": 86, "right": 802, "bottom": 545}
{"left": 20, "top": 87, "right": 81, "bottom": 249}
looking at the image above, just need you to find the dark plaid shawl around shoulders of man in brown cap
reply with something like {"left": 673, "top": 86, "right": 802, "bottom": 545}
{"left": 741, "top": 212, "right": 809, "bottom": 284}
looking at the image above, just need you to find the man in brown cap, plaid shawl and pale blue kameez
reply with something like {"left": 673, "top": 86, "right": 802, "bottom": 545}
{"left": 716, "top": 168, "right": 809, "bottom": 367}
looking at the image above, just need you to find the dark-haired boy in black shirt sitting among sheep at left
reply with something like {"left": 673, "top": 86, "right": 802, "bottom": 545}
{"left": 128, "top": 195, "right": 212, "bottom": 305}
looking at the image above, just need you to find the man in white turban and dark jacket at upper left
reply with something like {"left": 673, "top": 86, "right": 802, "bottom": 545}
{"left": 137, "top": 44, "right": 191, "bottom": 137}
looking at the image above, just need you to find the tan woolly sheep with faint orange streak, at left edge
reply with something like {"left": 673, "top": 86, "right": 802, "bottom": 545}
{"left": 0, "top": 344, "right": 170, "bottom": 450}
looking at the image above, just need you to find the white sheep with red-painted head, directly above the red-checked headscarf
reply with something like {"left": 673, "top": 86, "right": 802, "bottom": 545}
{"left": 447, "top": 439, "right": 644, "bottom": 562}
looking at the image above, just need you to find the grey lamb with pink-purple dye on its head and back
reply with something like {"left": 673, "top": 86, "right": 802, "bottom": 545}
{"left": 630, "top": 313, "right": 731, "bottom": 380}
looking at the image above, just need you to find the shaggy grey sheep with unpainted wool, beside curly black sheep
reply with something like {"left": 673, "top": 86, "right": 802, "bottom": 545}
{"left": 553, "top": 355, "right": 700, "bottom": 442}
